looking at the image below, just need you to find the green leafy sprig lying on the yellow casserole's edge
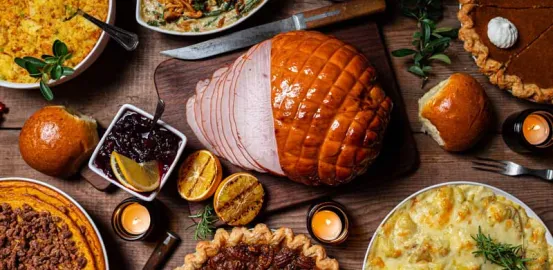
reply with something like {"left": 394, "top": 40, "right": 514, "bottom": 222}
{"left": 14, "top": 40, "right": 75, "bottom": 101}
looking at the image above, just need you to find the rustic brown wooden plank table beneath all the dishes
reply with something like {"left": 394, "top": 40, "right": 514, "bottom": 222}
{"left": 0, "top": 0, "right": 553, "bottom": 269}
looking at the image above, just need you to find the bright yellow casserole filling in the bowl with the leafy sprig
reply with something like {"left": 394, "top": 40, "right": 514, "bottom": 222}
{"left": 0, "top": 0, "right": 109, "bottom": 83}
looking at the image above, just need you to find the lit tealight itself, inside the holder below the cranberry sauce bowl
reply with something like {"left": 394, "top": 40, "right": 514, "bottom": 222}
{"left": 121, "top": 202, "right": 151, "bottom": 235}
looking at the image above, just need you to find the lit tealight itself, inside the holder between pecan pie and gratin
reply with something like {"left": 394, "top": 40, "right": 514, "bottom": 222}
{"left": 311, "top": 210, "right": 343, "bottom": 241}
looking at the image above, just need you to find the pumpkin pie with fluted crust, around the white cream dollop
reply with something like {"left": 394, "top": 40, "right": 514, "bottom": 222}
{"left": 458, "top": 0, "right": 553, "bottom": 103}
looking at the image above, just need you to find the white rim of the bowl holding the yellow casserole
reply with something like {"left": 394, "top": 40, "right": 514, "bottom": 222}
{"left": 0, "top": 0, "right": 115, "bottom": 89}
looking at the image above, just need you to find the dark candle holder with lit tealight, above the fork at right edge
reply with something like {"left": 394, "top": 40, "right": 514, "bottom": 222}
{"left": 502, "top": 109, "right": 553, "bottom": 154}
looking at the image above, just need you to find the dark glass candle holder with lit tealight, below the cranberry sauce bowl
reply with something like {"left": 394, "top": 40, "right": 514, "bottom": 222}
{"left": 111, "top": 197, "right": 159, "bottom": 241}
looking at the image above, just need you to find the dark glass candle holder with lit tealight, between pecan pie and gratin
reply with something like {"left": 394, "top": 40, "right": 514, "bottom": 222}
{"left": 307, "top": 201, "right": 349, "bottom": 245}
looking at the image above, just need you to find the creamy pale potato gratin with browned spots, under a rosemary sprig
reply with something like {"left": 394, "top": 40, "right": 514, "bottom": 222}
{"left": 366, "top": 185, "right": 553, "bottom": 270}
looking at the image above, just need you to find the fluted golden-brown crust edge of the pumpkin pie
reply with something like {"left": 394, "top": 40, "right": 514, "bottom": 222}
{"left": 458, "top": 0, "right": 553, "bottom": 103}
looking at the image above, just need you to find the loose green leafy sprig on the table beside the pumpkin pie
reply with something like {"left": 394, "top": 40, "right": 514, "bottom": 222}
{"left": 392, "top": 0, "right": 459, "bottom": 88}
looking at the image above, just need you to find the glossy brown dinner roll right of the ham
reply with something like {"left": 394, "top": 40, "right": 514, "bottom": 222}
{"left": 419, "top": 73, "right": 491, "bottom": 151}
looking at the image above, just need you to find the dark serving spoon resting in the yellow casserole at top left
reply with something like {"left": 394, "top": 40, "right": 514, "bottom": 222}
{"left": 65, "top": 8, "right": 139, "bottom": 51}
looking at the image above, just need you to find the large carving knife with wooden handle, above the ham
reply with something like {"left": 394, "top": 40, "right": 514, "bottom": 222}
{"left": 161, "top": 0, "right": 386, "bottom": 60}
